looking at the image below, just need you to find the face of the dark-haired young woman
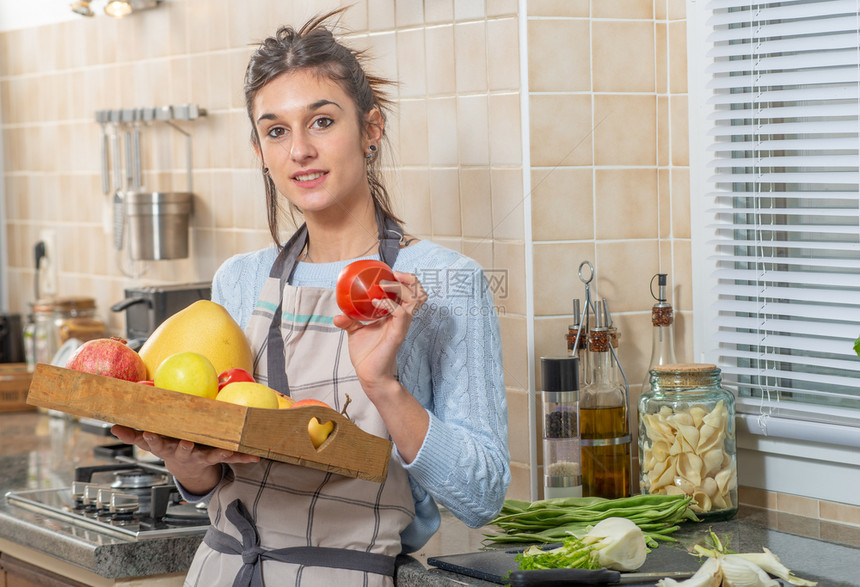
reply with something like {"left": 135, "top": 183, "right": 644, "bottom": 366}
{"left": 253, "top": 70, "right": 382, "bottom": 215}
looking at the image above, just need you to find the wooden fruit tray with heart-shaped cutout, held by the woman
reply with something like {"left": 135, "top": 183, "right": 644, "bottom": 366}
{"left": 27, "top": 363, "right": 391, "bottom": 482}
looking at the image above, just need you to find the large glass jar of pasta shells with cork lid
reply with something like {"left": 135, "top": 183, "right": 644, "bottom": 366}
{"left": 639, "top": 363, "right": 738, "bottom": 521}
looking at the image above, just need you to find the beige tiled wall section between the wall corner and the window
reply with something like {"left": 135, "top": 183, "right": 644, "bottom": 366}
{"left": 527, "top": 0, "right": 692, "bottom": 500}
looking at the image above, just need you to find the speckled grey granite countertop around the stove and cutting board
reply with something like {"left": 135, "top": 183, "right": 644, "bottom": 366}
{"left": 0, "top": 412, "right": 860, "bottom": 587}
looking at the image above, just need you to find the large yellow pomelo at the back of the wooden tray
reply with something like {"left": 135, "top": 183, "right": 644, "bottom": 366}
{"left": 138, "top": 300, "right": 254, "bottom": 379}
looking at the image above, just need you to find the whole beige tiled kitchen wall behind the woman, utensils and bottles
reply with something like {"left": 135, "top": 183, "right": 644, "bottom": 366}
{"left": 0, "top": 0, "right": 856, "bottom": 523}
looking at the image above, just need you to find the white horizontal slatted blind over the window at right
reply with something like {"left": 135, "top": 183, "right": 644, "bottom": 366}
{"left": 704, "top": 0, "right": 860, "bottom": 418}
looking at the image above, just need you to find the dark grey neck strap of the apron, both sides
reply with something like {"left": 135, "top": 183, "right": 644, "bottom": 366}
{"left": 266, "top": 211, "right": 404, "bottom": 395}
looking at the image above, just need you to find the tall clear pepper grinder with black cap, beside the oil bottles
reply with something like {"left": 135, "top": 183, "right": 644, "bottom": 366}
{"left": 540, "top": 356, "right": 582, "bottom": 499}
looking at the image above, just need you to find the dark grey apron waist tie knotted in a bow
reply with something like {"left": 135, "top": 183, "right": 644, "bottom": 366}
{"left": 203, "top": 499, "right": 395, "bottom": 587}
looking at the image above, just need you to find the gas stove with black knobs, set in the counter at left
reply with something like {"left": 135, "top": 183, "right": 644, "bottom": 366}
{"left": 6, "top": 445, "right": 209, "bottom": 539}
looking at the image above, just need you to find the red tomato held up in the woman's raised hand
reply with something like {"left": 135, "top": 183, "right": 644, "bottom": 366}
{"left": 336, "top": 259, "right": 400, "bottom": 322}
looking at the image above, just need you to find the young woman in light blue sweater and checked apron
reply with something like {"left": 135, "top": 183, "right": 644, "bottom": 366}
{"left": 115, "top": 12, "right": 510, "bottom": 587}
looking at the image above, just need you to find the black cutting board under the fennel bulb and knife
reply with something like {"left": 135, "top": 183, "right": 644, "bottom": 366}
{"left": 427, "top": 544, "right": 701, "bottom": 585}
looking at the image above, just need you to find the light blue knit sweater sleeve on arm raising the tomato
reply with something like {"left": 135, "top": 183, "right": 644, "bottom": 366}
{"left": 398, "top": 255, "right": 510, "bottom": 528}
